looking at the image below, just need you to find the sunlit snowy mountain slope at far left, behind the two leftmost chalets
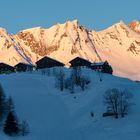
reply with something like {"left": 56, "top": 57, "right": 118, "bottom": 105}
{"left": 0, "top": 28, "right": 39, "bottom": 66}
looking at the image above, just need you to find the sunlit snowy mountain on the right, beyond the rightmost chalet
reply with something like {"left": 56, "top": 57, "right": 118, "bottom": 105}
{"left": 91, "top": 22, "right": 140, "bottom": 80}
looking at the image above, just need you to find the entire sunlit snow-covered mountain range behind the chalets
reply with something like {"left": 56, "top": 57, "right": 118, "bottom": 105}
{"left": 0, "top": 20, "right": 140, "bottom": 80}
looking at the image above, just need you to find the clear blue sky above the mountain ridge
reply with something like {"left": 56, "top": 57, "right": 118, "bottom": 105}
{"left": 0, "top": 0, "right": 140, "bottom": 33}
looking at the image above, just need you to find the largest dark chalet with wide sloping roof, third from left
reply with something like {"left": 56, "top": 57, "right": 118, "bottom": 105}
{"left": 36, "top": 56, "right": 64, "bottom": 69}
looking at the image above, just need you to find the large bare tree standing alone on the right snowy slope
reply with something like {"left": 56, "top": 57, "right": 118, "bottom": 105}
{"left": 104, "top": 88, "right": 132, "bottom": 118}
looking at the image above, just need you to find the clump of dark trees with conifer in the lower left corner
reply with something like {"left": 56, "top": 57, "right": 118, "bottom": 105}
{"left": 0, "top": 84, "right": 29, "bottom": 136}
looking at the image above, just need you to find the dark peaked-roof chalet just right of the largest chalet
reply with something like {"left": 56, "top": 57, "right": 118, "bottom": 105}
{"left": 69, "top": 57, "right": 91, "bottom": 67}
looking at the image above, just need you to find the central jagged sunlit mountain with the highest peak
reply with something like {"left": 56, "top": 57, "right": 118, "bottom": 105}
{"left": 16, "top": 20, "right": 101, "bottom": 64}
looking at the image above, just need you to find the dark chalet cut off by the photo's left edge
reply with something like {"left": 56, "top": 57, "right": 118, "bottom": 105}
{"left": 0, "top": 62, "right": 15, "bottom": 73}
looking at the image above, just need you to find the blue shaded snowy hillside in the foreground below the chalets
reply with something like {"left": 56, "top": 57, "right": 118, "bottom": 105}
{"left": 0, "top": 70, "right": 140, "bottom": 140}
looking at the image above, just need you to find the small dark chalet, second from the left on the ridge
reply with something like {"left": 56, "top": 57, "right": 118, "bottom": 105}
{"left": 14, "top": 63, "right": 33, "bottom": 72}
